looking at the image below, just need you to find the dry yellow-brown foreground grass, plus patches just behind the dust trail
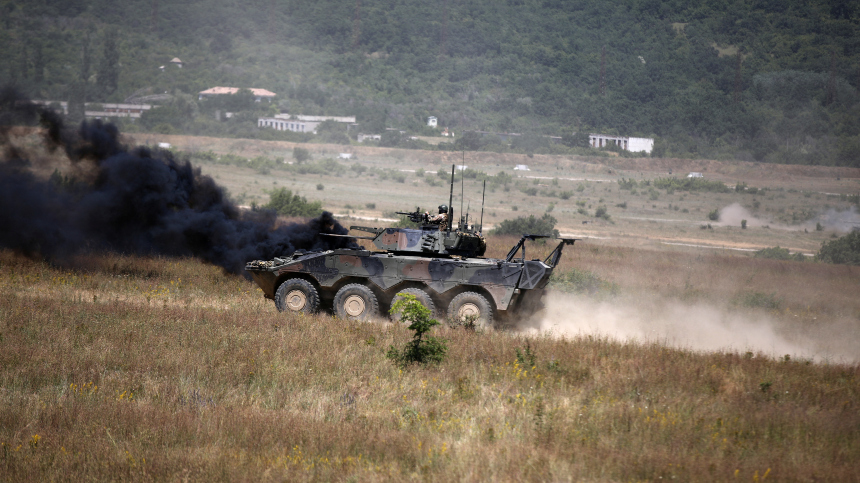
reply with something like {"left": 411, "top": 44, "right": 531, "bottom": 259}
{"left": 0, "top": 248, "right": 860, "bottom": 481}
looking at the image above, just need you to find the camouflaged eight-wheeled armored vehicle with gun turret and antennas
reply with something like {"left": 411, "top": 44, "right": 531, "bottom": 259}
{"left": 245, "top": 167, "right": 576, "bottom": 326}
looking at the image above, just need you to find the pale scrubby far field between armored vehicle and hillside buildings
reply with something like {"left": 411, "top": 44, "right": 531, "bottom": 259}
{"left": 134, "top": 131, "right": 860, "bottom": 254}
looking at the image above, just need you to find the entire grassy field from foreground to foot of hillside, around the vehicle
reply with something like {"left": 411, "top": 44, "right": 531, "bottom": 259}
{"left": 0, "top": 130, "right": 860, "bottom": 481}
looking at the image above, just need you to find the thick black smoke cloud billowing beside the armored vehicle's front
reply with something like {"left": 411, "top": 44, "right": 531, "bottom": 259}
{"left": 0, "top": 89, "right": 357, "bottom": 273}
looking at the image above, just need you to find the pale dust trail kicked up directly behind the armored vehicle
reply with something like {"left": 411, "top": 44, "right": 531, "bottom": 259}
{"left": 528, "top": 292, "right": 860, "bottom": 363}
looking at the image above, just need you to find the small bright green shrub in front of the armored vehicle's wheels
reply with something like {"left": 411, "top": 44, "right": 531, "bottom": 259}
{"left": 385, "top": 293, "right": 448, "bottom": 368}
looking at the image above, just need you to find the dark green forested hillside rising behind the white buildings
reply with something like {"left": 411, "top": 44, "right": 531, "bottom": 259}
{"left": 0, "top": 0, "right": 860, "bottom": 166}
